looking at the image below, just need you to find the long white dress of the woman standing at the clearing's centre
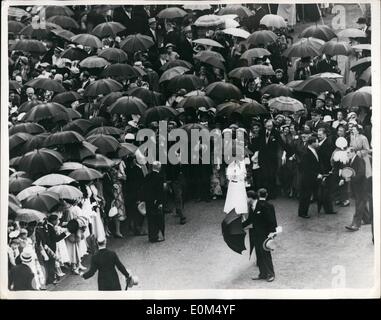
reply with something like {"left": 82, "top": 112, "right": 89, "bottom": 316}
{"left": 224, "top": 161, "right": 248, "bottom": 214}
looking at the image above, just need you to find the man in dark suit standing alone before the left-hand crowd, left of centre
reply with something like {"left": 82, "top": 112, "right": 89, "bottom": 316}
{"left": 139, "top": 161, "right": 164, "bottom": 242}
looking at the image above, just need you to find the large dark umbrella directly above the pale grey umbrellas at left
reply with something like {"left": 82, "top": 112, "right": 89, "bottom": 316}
{"left": 19, "top": 148, "right": 63, "bottom": 175}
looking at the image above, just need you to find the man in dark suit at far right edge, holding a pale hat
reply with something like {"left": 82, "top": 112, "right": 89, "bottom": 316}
{"left": 340, "top": 147, "right": 369, "bottom": 231}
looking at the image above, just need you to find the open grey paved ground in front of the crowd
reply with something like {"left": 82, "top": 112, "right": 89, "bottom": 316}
{"left": 55, "top": 199, "right": 374, "bottom": 290}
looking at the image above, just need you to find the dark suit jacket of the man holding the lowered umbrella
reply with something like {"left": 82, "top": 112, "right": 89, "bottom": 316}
{"left": 242, "top": 200, "right": 277, "bottom": 238}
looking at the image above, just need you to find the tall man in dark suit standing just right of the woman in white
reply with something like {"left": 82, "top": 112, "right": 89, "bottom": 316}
{"left": 258, "top": 120, "right": 284, "bottom": 199}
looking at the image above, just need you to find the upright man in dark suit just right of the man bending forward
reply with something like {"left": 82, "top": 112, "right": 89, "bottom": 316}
{"left": 317, "top": 128, "right": 336, "bottom": 214}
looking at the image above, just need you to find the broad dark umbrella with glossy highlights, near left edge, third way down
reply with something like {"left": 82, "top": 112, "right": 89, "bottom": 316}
{"left": 23, "top": 102, "right": 69, "bottom": 122}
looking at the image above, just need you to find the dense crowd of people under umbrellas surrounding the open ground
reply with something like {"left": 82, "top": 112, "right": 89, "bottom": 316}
{"left": 8, "top": 5, "right": 373, "bottom": 290}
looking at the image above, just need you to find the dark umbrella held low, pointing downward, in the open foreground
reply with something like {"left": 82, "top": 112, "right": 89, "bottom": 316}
{"left": 221, "top": 209, "right": 246, "bottom": 254}
